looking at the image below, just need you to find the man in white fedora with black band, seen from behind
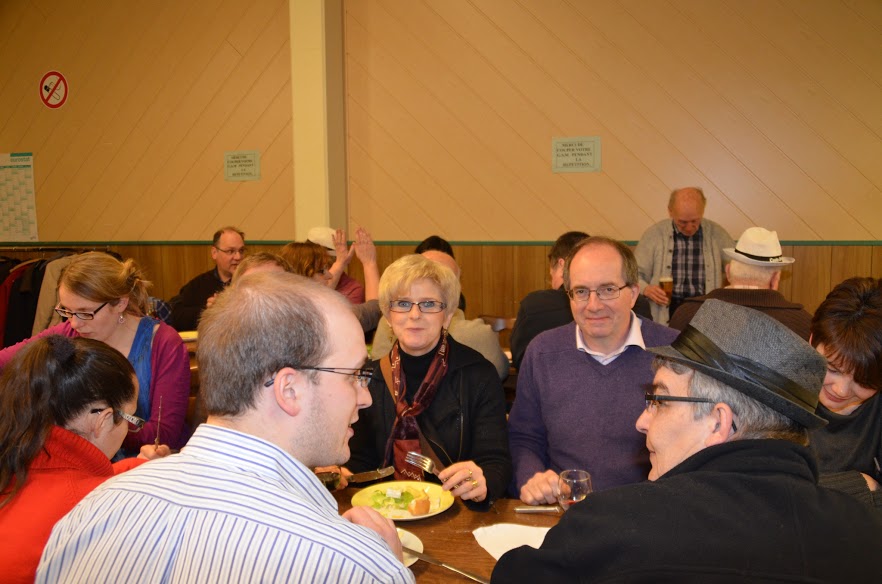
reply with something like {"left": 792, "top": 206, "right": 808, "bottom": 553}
{"left": 668, "top": 227, "right": 812, "bottom": 340}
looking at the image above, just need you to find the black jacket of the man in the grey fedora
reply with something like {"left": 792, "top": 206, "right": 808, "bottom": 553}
{"left": 492, "top": 440, "right": 882, "bottom": 584}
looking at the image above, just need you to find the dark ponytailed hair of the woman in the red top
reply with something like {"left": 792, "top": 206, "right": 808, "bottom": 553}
{"left": 0, "top": 335, "right": 136, "bottom": 507}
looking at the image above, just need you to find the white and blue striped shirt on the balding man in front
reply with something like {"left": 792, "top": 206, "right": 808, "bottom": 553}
{"left": 36, "top": 424, "right": 414, "bottom": 583}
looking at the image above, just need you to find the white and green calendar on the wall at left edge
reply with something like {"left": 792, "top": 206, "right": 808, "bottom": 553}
{"left": 0, "top": 152, "right": 37, "bottom": 241}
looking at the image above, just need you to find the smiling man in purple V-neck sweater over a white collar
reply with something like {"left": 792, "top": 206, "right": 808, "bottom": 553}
{"left": 509, "top": 237, "right": 677, "bottom": 505}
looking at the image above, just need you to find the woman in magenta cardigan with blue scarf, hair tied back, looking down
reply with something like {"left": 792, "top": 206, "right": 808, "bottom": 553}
{"left": 0, "top": 252, "right": 190, "bottom": 456}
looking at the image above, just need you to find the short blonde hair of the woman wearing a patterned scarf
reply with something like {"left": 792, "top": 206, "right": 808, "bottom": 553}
{"left": 379, "top": 254, "right": 462, "bottom": 318}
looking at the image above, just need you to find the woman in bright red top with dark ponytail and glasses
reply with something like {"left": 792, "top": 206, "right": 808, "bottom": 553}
{"left": 0, "top": 335, "right": 169, "bottom": 582}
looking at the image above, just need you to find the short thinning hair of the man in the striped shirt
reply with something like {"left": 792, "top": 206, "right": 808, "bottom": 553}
{"left": 197, "top": 272, "right": 338, "bottom": 416}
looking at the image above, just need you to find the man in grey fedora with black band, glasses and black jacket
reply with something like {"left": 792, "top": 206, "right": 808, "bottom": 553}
{"left": 492, "top": 300, "right": 882, "bottom": 583}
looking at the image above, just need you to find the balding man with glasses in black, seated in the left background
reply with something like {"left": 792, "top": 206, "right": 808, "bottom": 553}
{"left": 169, "top": 226, "right": 247, "bottom": 331}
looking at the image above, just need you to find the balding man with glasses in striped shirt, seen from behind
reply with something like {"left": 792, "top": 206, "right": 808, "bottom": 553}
{"left": 37, "top": 272, "right": 414, "bottom": 582}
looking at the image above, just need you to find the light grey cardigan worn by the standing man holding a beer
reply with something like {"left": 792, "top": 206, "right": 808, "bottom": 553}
{"left": 634, "top": 219, "right": 735, "bottom": 324}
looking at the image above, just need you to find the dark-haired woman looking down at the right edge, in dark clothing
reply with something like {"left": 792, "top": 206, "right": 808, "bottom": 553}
{"left": 810, "top": 278, "right": 882, "bottom": 504}
